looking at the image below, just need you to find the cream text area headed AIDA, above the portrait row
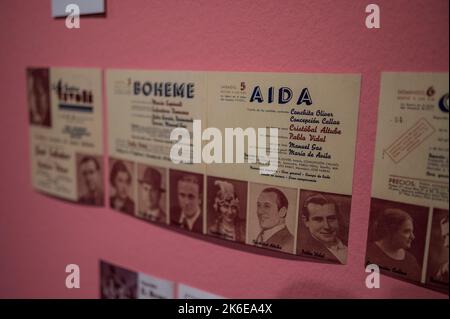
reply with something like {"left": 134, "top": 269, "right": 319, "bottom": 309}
{"left": 208, "top": 72, "right": 360, "bottom": 195}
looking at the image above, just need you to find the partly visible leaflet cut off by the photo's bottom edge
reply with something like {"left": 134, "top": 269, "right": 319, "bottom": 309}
{"left": 100, "top": 260, "right": 223, "bottom": 299}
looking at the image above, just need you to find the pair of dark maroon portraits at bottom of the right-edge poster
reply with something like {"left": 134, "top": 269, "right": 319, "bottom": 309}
{"left": 366, "top": 198, "right": 449, "bottom": 290}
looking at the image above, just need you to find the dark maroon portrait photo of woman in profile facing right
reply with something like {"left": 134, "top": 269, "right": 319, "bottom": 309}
{"left": 366, "top": 198, "right": 428, "bottom": 282}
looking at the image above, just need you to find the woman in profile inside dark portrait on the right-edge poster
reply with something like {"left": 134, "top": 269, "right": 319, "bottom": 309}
{"left": 367, "top": 208, "right": 421, "bottom": 281}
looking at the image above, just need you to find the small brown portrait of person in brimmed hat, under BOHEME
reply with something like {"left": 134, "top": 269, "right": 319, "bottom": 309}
{"left": 137, "top": 164, "right": 168, "bottom": 224}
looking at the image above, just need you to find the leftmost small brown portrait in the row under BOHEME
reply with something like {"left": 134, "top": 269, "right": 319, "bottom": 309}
{"left": 109, "top": 158, "right": 135, "bottom": 215}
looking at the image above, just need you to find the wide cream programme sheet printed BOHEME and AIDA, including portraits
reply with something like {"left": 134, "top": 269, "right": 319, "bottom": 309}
{"left": 106, "top": 70, "right": 360, "bottom": 263}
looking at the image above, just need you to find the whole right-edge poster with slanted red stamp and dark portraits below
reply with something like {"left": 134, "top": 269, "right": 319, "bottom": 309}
{"left": 366, "top": 73, "right": 449, "bottom": 291}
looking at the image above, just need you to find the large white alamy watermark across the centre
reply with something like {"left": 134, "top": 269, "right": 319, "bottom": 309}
{"left": 170, "top": 120, "right": 278, "bottom": 175}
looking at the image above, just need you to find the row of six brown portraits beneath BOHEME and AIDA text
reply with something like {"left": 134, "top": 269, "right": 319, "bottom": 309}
{"left": 109, "top": 158, "right": 351, "bottom": 264}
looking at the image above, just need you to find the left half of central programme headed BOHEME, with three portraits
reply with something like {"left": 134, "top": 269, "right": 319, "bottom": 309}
{"left": 106, "top": 70, "right": 206, "bottom": 233}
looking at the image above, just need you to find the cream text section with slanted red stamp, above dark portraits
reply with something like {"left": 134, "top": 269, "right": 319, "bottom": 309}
{"left": 372, "top": 73, "right": 448, "bottom": 208}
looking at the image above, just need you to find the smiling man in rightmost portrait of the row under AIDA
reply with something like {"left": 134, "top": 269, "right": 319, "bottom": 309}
{"left": 300, "top": 192, "right": 347, "bottom": 264}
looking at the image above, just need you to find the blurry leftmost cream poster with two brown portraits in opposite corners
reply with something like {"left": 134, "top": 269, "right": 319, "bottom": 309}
{"left": 27, "top": 68, "right": 104, "bottom": 206}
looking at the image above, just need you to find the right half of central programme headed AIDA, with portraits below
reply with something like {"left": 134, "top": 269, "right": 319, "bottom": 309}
{"left": 207, "top": 72, "right": 360, "bottom": 264}
